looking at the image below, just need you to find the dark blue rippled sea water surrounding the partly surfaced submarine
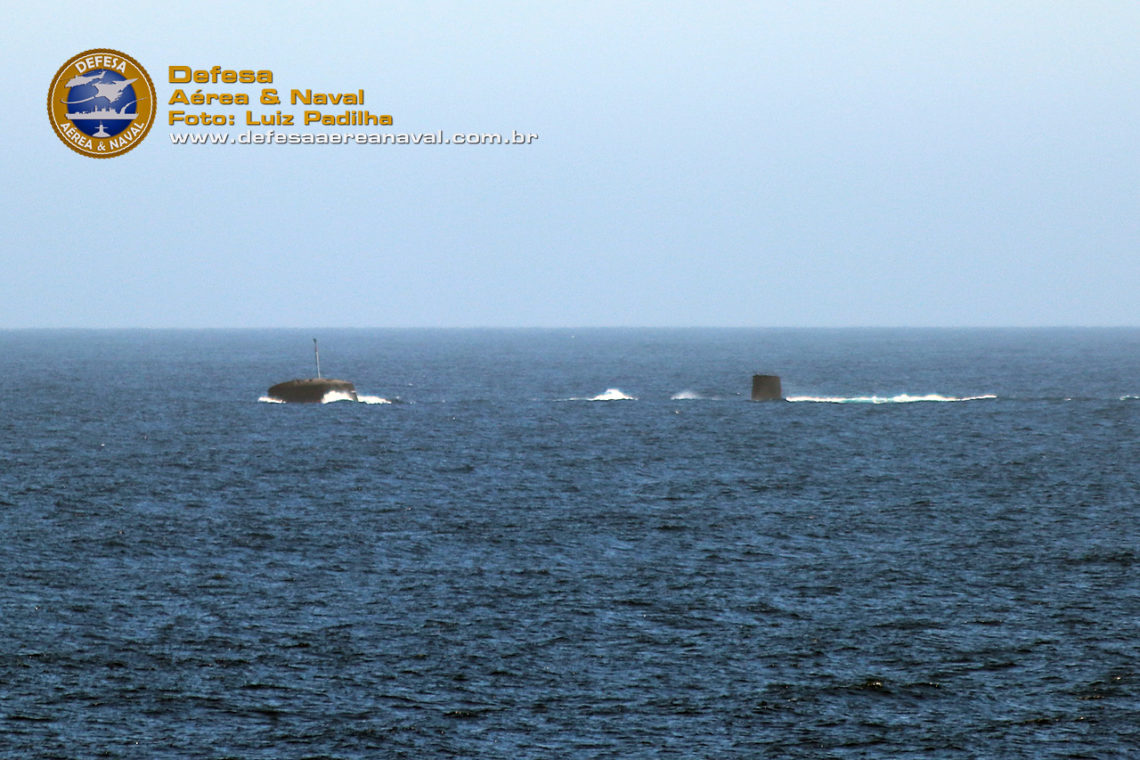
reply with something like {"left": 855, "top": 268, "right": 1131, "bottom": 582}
{"left": 0, "top": 329, "right": 1140, "bottom": 760}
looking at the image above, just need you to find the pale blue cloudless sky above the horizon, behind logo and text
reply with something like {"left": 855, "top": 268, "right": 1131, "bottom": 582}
{"left": 0, "top": 0, "right": 1140, "bottom": 328}
